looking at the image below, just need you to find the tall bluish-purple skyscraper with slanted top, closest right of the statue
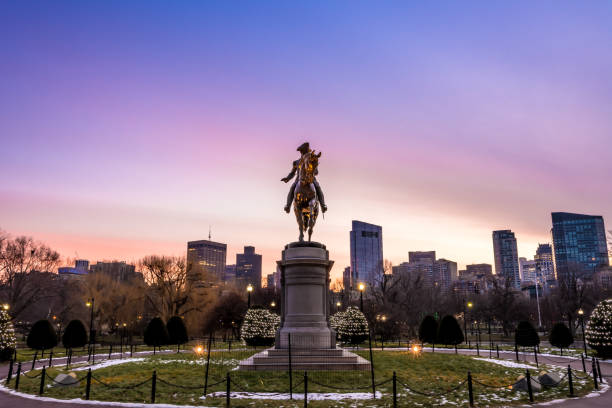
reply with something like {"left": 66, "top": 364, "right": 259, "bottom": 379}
{"left": 350, "top": 220, "right": 383, "bottom": 286}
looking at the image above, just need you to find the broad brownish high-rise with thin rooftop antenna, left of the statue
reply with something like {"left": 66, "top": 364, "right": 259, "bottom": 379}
{"left": 187, "top": 240, "right": 227, "bottom": 284}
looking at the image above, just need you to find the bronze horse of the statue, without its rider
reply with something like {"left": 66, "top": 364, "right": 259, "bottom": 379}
{"left": 293, "top": 150, "right": 321, "bottom": 242}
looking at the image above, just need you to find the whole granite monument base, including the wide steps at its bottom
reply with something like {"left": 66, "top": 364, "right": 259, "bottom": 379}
{"left": 240, "top": 242, "right": 370, "bottom": 370}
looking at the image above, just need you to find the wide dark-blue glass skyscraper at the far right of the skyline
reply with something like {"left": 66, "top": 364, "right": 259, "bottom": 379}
{"left": 552, "top": 212, "right": 610, "bottom": 280}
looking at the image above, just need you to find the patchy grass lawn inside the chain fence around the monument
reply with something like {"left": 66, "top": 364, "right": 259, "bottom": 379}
{"left": 4, "top": 350, "right": 592, "bottom": 407}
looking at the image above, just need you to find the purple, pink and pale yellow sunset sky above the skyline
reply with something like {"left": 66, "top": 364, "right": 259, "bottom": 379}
{"left": 0, "top": 1, "right": 612, "bottom": 282}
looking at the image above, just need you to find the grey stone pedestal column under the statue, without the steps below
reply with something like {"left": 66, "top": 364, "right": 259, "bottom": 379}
{"left": 275, "top": 242, "right": 336, "bottom": 349}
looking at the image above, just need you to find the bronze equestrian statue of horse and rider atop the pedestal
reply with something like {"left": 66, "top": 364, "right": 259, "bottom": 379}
{"left": 281, "top": 142, "right": 327, "bottom": 242}
